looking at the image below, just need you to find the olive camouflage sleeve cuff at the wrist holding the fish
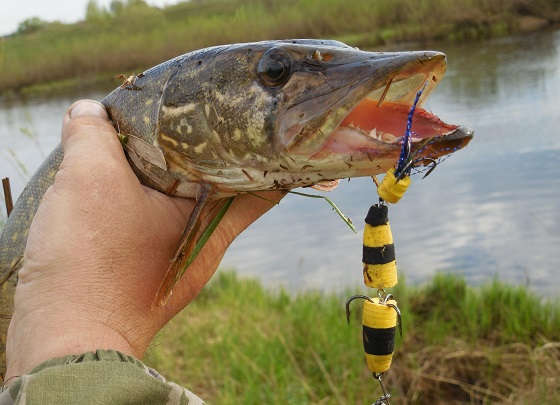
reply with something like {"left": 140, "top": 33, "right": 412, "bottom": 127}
{"left": 0, "top": 350, "right": 204, "bottom": 405}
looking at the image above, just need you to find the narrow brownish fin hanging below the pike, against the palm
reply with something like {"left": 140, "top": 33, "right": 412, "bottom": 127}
{"left": 152, "top": 185, "right": 234, "bottom": 307}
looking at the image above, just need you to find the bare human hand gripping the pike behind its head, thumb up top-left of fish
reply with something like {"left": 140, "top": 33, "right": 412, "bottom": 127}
{"left": 6, "top": 100, "right": 284, "bottom": 379}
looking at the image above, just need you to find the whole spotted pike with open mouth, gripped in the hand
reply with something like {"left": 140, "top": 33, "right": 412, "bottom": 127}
{"left": 0, "top": 39, "right": 473, "bottom": 374}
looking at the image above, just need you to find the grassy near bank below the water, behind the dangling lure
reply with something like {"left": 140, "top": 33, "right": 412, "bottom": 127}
{"left": 146, "top": 271, "right": 560, "bottom": 404}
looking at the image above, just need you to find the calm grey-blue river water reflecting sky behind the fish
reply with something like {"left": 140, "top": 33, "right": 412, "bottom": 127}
{"left": 0, "top": 31, "right": 560, "bottom": 296}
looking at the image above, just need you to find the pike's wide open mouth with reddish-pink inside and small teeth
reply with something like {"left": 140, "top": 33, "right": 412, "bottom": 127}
{"left": 312, "top": 52, "right": 473, "bottom": 164}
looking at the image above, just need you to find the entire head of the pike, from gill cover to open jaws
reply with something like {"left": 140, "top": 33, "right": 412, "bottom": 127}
{"left": 159, "top": 39, "right": 472, "bottom": 178}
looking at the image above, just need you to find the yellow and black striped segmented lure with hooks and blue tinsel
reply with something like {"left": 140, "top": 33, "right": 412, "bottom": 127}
{"left": 346, "top": 85, "right": 437, "bottom": 405}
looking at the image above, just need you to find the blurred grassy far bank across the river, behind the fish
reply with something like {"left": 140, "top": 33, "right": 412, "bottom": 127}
{"left": 0, "top": 0, "right": 560, "bottom": 93}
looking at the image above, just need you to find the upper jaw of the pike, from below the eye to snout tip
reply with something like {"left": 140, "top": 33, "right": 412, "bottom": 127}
{"left": 277, "top": 49, "right": 446, "bottom": 156}
